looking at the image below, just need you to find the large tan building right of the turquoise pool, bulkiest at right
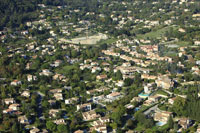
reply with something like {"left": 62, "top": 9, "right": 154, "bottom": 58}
{"left": 155, "top": 75, "right": 174, "bottom": 89}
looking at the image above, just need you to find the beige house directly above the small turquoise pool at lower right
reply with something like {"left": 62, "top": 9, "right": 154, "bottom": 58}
{"left": 154, "top": 111, "right": 172, "bottom": 123}
